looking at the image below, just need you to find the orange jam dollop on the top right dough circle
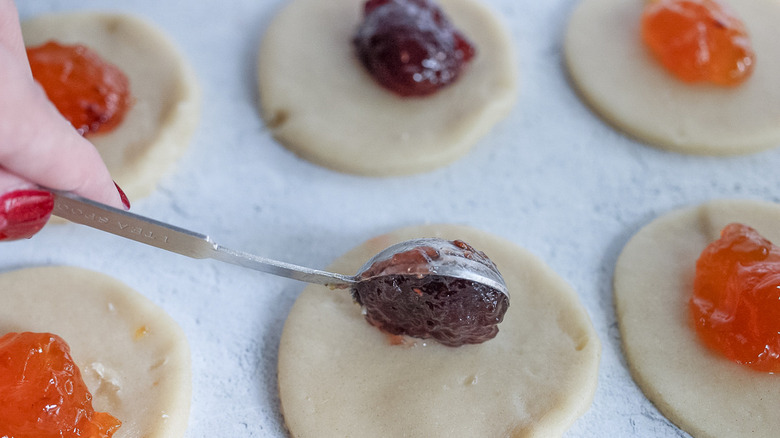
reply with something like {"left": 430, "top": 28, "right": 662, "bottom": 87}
{"left": 641, "top": 0, "right": 755, "bottom": 86}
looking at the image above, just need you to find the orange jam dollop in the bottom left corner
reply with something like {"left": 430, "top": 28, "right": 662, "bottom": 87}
{"left": 0, "top": 332, "right": 121, "bottom": 438}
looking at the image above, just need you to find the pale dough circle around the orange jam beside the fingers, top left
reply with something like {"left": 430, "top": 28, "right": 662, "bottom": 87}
{"left": 22, "top": 12, "right": 200, "bottom": 200}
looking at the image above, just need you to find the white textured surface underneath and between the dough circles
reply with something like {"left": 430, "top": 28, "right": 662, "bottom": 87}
{"left": 6, "top": 0, "right": 780, "bottom": 437}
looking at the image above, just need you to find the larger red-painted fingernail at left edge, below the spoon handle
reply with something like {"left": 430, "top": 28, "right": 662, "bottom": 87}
{"left": 0, "top": 190, "right": 54, "bottom": 241}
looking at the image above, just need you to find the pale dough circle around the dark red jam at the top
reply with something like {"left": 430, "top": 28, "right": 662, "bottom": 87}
{"left": 258, "top": 0, "right": 517, "bottom": 176}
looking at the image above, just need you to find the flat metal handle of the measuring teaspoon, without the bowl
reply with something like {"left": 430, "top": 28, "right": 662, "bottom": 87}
{"left": 54, "top": 189, "right": 355, "bottom": 288}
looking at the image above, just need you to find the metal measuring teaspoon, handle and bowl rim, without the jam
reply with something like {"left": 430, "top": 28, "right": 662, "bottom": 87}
{"left": 47, "top": 189, "right": 509, "bottom": 299}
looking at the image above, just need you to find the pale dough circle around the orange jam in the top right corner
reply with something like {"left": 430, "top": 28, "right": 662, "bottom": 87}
{"left": 564, "top": 0, "right": 780, "bottom": 155}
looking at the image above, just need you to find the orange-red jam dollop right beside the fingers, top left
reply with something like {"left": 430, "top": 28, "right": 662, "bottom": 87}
{"left": 27, "top": 41, "right": 133, "bottom": 135}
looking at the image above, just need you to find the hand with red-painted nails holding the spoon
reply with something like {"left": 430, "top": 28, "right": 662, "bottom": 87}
{"left": 0, "top": 0, "right": 130, "bottom": 241}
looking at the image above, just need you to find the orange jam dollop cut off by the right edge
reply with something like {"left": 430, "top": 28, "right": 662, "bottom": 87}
{"left": 690, "top": 223, "right": 780, "bottom": 373}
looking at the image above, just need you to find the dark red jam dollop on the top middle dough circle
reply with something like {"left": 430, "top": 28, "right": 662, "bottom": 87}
{"left": 353, "top": 0, "right": 476, "bottom": 97}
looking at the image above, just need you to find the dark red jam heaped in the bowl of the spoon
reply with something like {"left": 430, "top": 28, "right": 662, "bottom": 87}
{"left": 352, "top": 241, "right": 509, "bottom": 347}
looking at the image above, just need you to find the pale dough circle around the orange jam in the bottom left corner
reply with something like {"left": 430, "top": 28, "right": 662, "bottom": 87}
{"left": 0, "top": 267, "right": 192, "bottom": 438}
